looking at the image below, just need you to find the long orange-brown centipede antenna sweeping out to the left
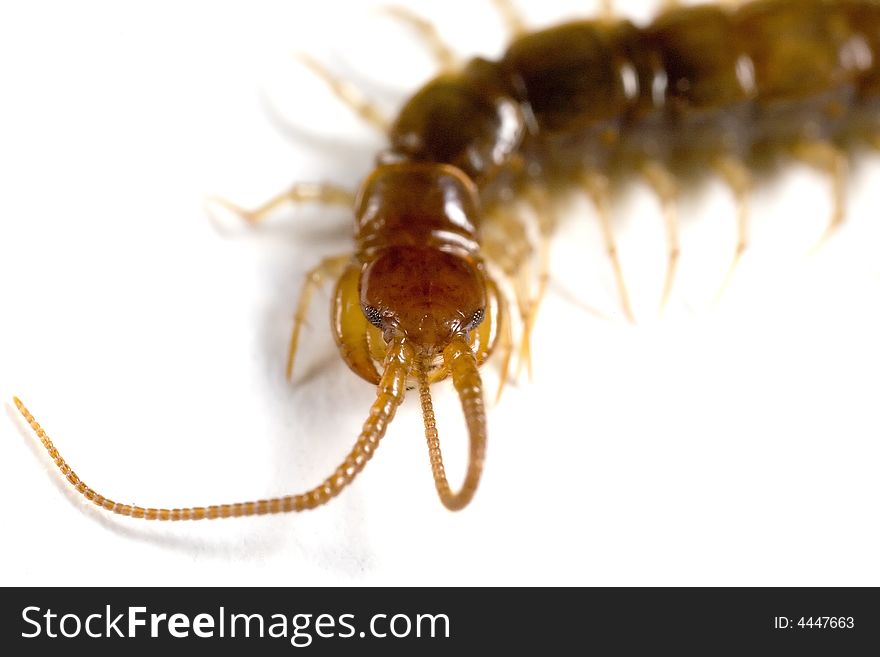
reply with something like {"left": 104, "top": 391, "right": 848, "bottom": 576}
{"left": 13, "top": 342, "right": 413, "bottom": 520}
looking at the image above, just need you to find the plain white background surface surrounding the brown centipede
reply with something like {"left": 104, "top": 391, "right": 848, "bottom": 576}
{"left": 0, "top": 0, "right": 880, "bottom": 585}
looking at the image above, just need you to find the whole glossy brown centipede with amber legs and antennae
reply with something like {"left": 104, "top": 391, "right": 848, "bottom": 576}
{"left": 8, "top": 0, "right": 880, "bottom": 521}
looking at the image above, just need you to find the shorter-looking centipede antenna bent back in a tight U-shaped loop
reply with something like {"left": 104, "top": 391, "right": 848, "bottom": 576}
{"left": 415, "top": 337, "right": 486, "bottom": 511}
